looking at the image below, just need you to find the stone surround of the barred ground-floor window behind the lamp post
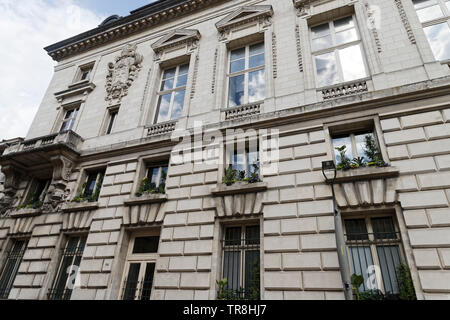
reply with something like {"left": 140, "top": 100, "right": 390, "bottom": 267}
{"left": 339, "top": 204, "right": 423, "bottom": 300}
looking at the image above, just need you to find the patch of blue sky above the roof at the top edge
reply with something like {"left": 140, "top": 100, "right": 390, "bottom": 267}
{"left": 75, "top": 0, "right": 153, "bottom": 16}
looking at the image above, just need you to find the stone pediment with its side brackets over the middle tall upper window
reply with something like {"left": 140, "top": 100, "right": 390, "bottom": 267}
{"left": 216, "top": 6, "right": 273, "bottom": 40}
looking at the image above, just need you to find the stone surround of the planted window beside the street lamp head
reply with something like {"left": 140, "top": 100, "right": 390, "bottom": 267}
{"left": 324, "top": 115, "right": 389, "bottom": 163}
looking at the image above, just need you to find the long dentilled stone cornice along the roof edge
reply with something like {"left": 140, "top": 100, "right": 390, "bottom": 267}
{"left": 45, "top": 0, "right": 223, "bottom": 61}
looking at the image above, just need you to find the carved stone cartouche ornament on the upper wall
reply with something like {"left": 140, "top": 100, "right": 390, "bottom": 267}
{"left": 106, "top": 44, "right": 144, "bottom": 104}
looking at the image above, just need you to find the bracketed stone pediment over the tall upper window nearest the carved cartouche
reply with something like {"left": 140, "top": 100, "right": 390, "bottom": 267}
{"left": 152, "top": 29, "right": 201, "bottom": 60}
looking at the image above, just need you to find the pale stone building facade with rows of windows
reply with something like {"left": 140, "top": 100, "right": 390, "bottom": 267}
{"left": 0, "top": 0, "right": 450, "bottom": 300}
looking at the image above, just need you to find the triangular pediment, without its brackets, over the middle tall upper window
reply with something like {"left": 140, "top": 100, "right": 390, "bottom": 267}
{"left": 216, "top": 6, "right": 273, "bottom": 32}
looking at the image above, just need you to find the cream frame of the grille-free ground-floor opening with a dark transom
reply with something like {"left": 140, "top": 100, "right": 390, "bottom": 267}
{"left": 118, "top": 227, "right": 162, "bottom": 300}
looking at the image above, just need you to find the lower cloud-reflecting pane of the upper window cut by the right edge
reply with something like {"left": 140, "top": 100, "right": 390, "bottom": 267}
{"left": 423, "top": 23, "right": 450, "bottom": 60}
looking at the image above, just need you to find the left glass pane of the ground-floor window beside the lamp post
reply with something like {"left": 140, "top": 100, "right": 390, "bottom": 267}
{"left": 348, "top": 246, "right": 378, "bottom": 292}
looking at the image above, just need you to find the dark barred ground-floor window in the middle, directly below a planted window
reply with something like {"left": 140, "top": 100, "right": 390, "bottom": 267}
{"left": 219, "top": 225, "right": 260, "bottom": 300}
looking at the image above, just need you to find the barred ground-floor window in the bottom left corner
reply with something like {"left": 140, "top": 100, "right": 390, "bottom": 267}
{"left": 0, "top": 240, "right": 28, "bottom": 299}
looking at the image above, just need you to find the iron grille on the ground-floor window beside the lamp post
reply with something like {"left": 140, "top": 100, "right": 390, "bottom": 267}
{"left": 345, "top": 231, "right": 404, "bottom": 296}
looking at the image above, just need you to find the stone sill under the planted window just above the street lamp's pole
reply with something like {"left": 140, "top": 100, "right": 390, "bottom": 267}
{"left": 335, "top": 167, "right": 400, "bottom": 183}
